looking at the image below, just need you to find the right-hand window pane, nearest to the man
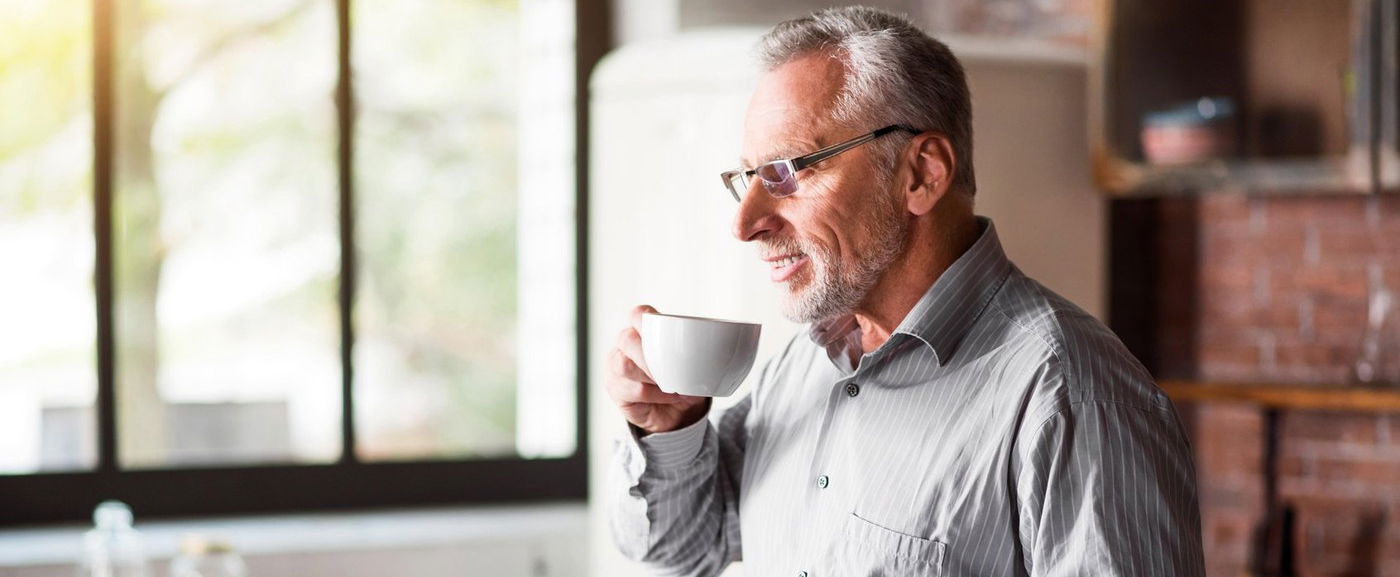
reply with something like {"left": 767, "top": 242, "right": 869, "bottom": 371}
{"left": 351, "top": 0, "right": 577, "bottom": 459}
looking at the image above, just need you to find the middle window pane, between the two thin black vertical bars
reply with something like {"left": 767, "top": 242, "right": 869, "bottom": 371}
{"left": 115, "top": 0, "right": 342, "bottom": 466}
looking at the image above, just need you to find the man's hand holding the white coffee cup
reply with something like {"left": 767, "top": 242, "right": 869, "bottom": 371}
{"left": 603, "top": 305, "right": 710, "bottom": 434}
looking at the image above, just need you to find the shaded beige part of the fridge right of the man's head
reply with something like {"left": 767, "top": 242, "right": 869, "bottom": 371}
{"left": 949, "top": 38, "right": 1109, "bottom": 319}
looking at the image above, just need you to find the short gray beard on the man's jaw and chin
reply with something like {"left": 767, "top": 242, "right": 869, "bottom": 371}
{"left": 783, "top": 193, "right": 909, "bottom": 324}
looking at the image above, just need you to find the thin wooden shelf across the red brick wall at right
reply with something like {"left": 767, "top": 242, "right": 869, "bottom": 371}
{"left": 1158, "top": 381, "right": 1400, "bottom": 413}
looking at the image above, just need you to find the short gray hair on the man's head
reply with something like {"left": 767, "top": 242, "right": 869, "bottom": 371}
{"left": 759, "top": 6, "right": 977, "bottom": 197}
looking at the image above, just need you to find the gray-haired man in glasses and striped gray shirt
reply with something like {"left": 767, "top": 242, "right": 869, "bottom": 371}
{"left": 606, "top": 8, "right": 1204, "bottom": 577}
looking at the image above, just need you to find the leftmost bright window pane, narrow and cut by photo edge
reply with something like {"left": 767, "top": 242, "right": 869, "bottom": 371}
{"left": 0, "top": 0, "right": 97, "bottom": 473}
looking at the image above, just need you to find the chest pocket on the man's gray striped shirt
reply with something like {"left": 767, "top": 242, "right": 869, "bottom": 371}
{"left": 833, "top": 513, "right": 946, "bottom": 577}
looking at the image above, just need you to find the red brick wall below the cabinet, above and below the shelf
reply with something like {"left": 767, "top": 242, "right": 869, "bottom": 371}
{"left": 1155, "top": 195, "right": 1400, "bottom": 577}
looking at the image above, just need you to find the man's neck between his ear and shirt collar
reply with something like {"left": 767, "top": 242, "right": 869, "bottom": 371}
{"left": 855, "top": 213, "right": 977, "bottom": 353}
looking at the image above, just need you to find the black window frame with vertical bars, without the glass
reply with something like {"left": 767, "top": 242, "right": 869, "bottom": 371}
{"left": 0, "top": 0, "right": 610, "bottom": 527}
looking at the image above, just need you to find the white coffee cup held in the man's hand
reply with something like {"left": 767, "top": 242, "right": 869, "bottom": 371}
{"left": 641, "top": 312, "right": 763, "bottom": 396}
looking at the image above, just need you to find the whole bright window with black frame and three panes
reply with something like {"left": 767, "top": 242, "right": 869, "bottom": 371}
{"left": 0, "top": 0, "right": 601, "bottom": 524}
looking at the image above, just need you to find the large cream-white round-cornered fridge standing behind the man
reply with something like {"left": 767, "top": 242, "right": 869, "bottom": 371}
{"left": 588, "top": 29, "right": 1105, "bottom": 577}
